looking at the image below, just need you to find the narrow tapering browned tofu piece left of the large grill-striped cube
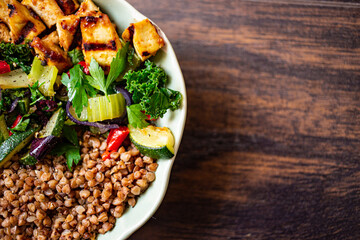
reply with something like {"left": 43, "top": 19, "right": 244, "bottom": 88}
{"left": 56, "top": 15, "right": 80, "bottom": 51}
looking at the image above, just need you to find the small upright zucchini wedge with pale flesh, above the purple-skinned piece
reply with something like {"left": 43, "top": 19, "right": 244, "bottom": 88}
{"left": 39, "top": 108, "right": 66, "bottom": 138}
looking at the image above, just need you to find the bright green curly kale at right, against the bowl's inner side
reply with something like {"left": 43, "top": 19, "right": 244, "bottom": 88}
{"left": 124, "top": 60, "right": 182, "bottom": 119}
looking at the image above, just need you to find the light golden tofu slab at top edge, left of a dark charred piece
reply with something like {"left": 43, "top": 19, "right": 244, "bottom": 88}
{"left": 21, "top": 0, "right": 64, "bottom": 28}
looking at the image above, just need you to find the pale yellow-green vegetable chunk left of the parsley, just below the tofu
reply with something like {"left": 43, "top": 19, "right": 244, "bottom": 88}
{"left": 28, "top": 57, "right": 58, "bottom": 97}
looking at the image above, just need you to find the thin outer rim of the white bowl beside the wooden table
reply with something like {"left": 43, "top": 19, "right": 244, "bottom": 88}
{"left": 94, "top": 0, "right": 187, "bottom": 240}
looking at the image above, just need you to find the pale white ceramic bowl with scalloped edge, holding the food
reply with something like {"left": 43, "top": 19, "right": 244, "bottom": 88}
{"left": 94, "top": 0, "right": 187, "bottom": 240}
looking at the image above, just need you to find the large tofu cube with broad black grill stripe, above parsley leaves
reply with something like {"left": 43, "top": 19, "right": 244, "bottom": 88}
{"left": 80, "top": 13, "right": 122, "bottom": 72}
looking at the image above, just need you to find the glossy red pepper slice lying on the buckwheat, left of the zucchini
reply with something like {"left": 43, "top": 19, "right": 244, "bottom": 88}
{"left": 102, "top": 126, "right": 129, "bottom": 160}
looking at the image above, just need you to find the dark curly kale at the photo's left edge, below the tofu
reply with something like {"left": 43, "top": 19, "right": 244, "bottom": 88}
{"left": 0, "top": 42, "right": 34, "bottom": 74}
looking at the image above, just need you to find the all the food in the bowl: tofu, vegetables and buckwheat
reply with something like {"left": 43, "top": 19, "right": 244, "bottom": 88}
{"left": 0, "top": 0, "right": 182, "bottom": 239}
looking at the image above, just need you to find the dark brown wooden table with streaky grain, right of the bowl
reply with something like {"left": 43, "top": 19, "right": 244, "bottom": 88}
{"left": 129, "top": 0, "right": 360, "bottom": 239}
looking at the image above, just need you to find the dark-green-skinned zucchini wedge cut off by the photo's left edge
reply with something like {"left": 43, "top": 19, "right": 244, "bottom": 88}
{"left": 0, "top": 128, "right": 38, "bottom": 167}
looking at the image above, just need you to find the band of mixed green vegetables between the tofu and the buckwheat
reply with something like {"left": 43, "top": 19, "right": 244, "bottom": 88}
{"left": 0, "top": 40, "right": 182, "bottom": 169}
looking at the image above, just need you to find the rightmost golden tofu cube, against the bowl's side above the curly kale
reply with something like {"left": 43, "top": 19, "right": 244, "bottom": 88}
{"left": 122, "top": 19, "right": 165, "bottom": 61}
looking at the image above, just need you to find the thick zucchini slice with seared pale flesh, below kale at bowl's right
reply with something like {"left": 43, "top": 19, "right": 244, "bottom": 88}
{"left": 129, "top": 125, "right": 175, "bottom": 159}
